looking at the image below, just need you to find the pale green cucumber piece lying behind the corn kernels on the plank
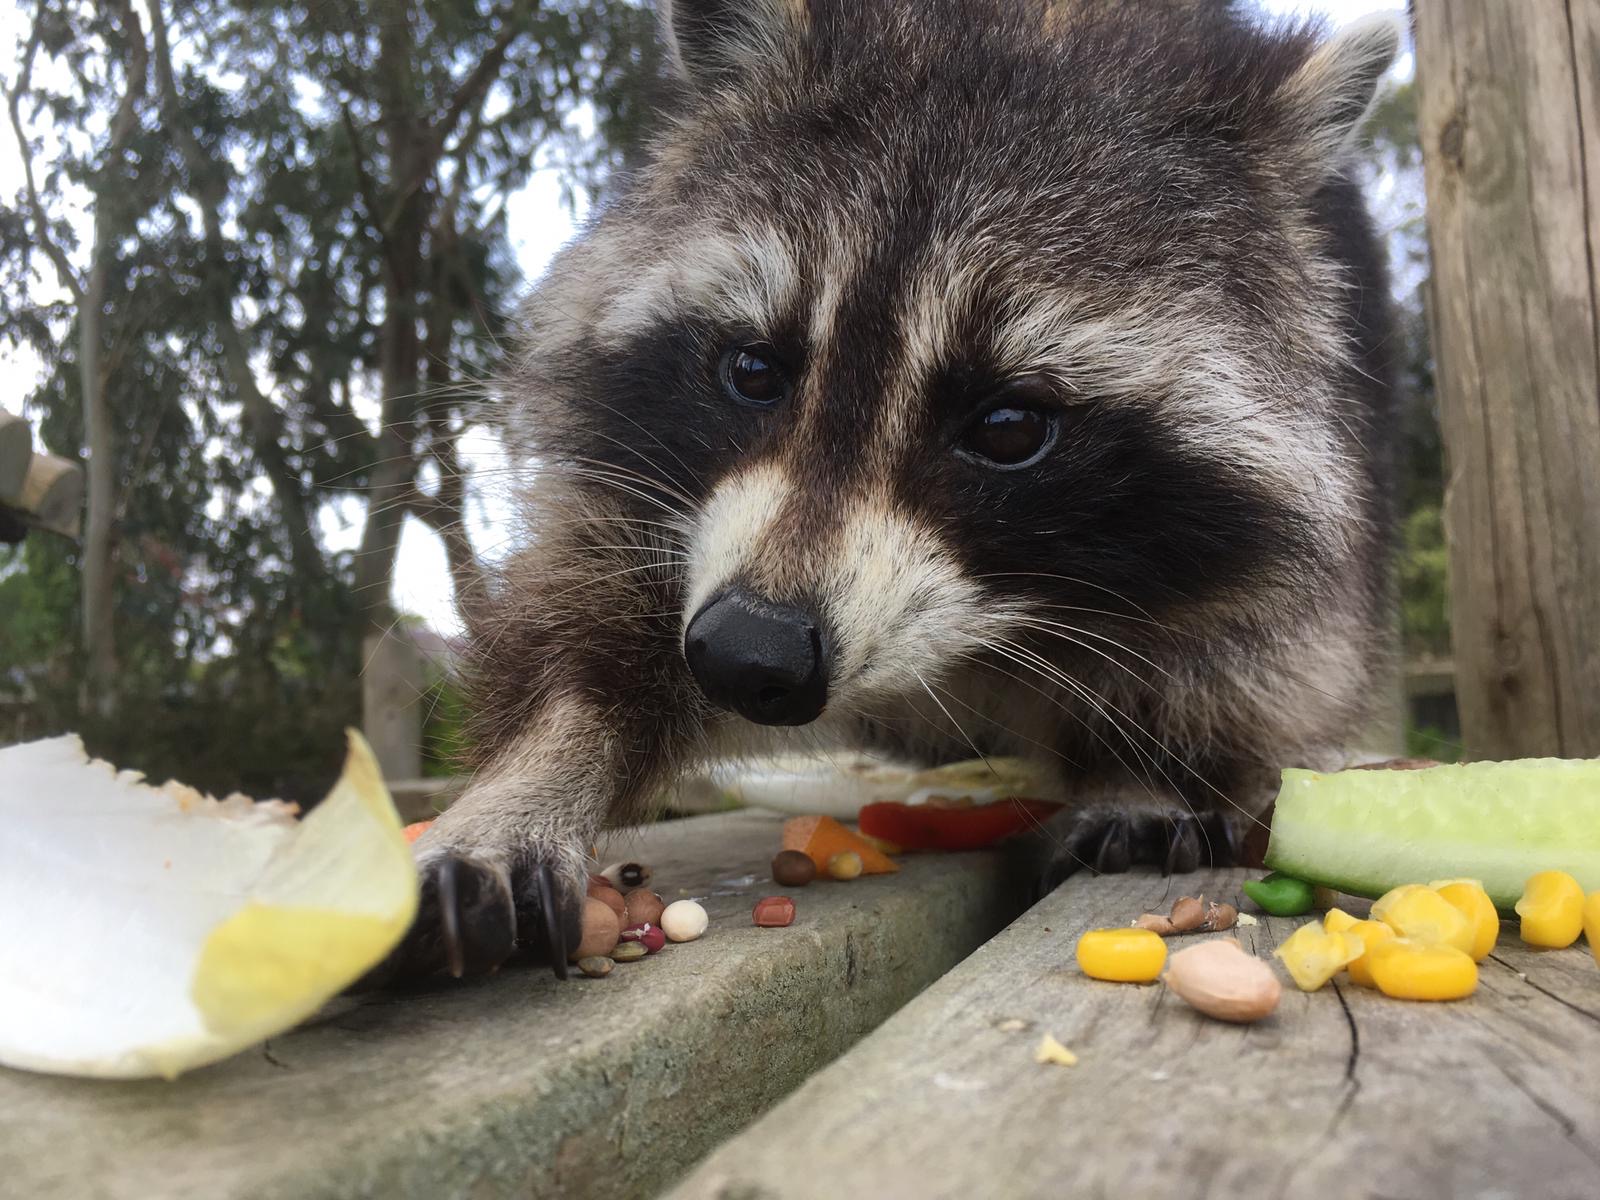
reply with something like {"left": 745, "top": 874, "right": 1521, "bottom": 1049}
{"left": 1266, "top": 758, "right": 1600, "bottom": 910}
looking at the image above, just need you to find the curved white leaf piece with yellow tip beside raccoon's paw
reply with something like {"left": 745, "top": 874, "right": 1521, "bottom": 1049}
{"left": 0, "top": 731, "right": 418, "bottom": 1078}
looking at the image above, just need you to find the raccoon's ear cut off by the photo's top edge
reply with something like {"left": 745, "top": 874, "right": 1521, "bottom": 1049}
{"left": 658, "top": 0, "right": 810, "bottom": 88}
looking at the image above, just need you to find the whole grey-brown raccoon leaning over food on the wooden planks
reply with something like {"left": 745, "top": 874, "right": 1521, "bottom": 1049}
{"left": 392, "top": 0, "right": 1400, "bottom": 974}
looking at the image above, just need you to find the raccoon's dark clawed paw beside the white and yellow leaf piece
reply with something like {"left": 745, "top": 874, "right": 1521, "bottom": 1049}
{"left": 357, "top": 848, "right": 582, "bottom": 989}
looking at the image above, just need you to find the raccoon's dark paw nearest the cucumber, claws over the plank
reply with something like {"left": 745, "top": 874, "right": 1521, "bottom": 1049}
{"left": 1038, "top": 805, "right": 1242, "bottom": 894}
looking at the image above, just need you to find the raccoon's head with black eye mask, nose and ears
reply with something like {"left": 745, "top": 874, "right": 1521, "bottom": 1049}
{"left": 526, "top": 0, "right": 1397, "bottom": 725}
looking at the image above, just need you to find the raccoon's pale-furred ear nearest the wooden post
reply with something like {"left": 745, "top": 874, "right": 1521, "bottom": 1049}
{"left": 1278, "top": 13, "right": 1405, "bottom": 182}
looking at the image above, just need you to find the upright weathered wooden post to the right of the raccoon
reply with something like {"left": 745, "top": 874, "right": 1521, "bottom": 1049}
{"left": 1414, "top": 0, "right": 1600, "bottom": 758}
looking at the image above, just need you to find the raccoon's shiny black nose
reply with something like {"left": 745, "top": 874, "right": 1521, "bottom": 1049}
{"left": 683, "top": 589, "right": 827, "bottom": 725}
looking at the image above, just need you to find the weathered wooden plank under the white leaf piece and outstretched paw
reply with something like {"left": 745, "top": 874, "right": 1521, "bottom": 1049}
{"left": 0, "top": 813, "right": 1024, "bottom": 1200}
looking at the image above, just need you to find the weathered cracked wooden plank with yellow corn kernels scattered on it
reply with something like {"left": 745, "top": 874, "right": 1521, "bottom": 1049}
{"left": 669, "top": 874, "right": 1600, "bottom": 1200}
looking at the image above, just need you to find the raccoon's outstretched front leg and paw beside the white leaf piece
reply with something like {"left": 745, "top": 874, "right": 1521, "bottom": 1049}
{"left": 378, "top": 501, "right": 701, "bottom": 981}
